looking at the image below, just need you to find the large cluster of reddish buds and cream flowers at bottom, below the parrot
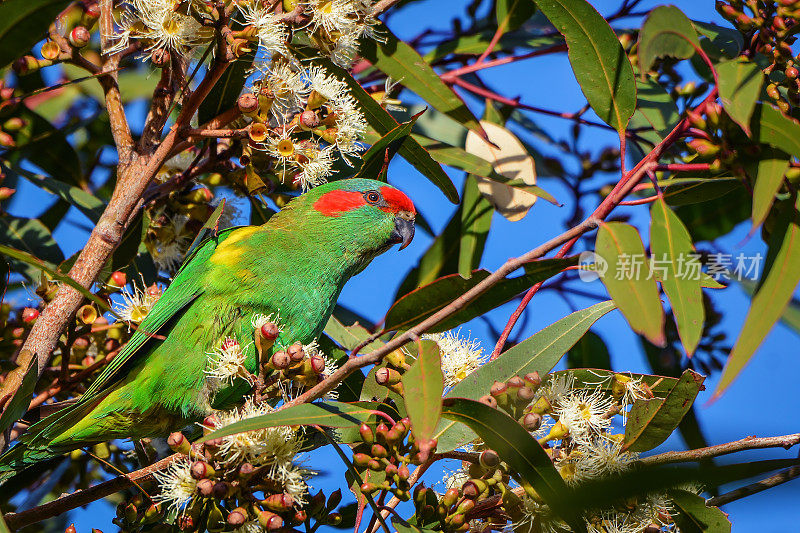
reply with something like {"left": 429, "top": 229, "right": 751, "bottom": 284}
{"left": 139, "top": 399, "right": 320, "bottom": 532}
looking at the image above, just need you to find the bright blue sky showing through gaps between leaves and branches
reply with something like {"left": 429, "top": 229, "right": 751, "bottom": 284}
{"left": 7, "top": 0, "right": 800, "bottom": 532}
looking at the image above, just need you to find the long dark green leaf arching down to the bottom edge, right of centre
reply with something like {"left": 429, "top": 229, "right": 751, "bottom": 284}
{"left": 442, "top": 398, "right": 586, "bottom": 533}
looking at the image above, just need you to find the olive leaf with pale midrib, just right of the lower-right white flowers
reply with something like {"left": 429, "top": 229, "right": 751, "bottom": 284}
{"left": 622, "top": 370, "right": 705, "bottom": 452}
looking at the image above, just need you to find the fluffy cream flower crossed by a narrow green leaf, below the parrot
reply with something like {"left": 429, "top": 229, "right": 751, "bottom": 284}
{"left": 214, "top": 398, "right": 301, "bottom": 466}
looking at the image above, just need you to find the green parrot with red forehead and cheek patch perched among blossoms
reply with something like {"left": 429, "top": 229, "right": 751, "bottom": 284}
{"left": 0, "top": 179, "right": 416, "bottom": 482}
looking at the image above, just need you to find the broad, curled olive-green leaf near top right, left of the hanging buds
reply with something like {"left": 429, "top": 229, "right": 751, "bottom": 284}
{"left": 639, "top": 6, "right": 700, "bottom": 73}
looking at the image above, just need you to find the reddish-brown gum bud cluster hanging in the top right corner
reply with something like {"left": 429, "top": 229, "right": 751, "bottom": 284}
{"left": 716, "top": 0, "right": 800, "bottom": 113}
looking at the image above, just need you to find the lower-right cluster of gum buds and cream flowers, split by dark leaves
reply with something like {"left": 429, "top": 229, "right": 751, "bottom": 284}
{"left": 482, "top": 372, "right": 674, "bottom": 533}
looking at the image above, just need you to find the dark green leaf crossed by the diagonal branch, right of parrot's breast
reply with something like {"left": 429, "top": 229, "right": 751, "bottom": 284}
{"left": 384, "top": 257, "right": 577, "bottom": 332}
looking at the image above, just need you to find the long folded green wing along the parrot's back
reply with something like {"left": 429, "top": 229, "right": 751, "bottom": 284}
{"left": 79, "top": 228, "right": 241, "bottom": 403}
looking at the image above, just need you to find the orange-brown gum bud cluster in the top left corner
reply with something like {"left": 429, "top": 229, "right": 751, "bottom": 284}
{"left": 12, "top": 0, "right": 100, "bottom": 75}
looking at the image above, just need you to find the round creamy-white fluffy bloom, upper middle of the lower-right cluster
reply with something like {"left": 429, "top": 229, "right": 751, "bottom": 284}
{"left": 554, "top": 389, "right": 616, "bottom": 442}
